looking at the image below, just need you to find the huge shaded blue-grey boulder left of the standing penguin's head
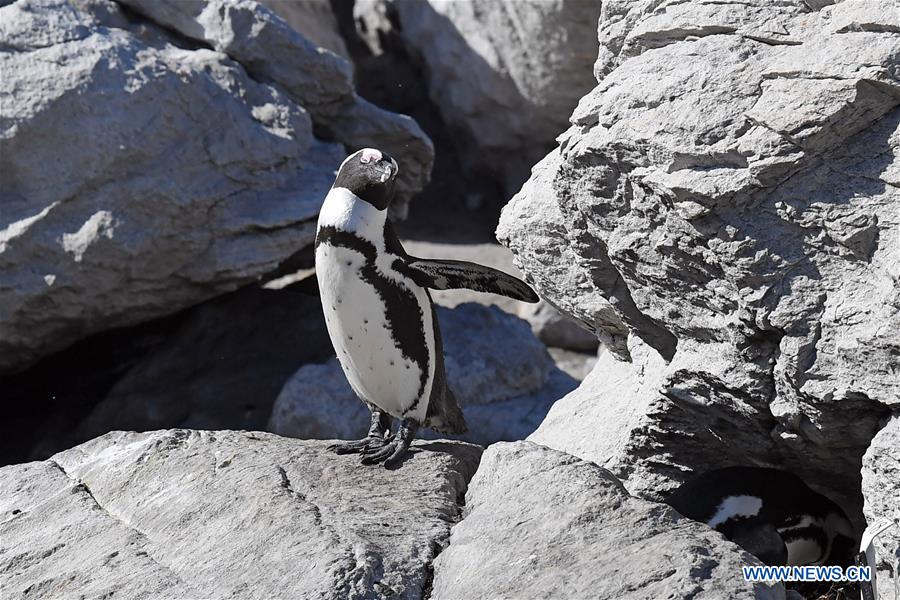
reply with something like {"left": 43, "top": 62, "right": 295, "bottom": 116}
{"left": 0, "top": 0, "right": 432, "bottom": 371}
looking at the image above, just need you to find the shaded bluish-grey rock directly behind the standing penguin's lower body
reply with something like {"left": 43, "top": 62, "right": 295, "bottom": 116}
{"left": 267, "top": 304, "right": 577, "bottom": 444}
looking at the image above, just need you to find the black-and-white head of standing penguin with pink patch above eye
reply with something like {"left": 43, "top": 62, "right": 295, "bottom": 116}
{"left": 332, "top": 148, "right": 400, "bottom": 210}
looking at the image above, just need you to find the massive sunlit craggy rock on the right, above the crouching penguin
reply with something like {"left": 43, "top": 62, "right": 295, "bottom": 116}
{"left": 498, "top": 2, "right": 900, "bottom": 514}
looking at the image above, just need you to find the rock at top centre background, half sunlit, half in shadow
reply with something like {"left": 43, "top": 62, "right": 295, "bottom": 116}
{"left": 354, "top": 0, "right": 600, "bottom": 194}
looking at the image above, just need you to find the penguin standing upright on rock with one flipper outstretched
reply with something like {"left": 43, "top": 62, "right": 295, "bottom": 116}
{"left": 315, "top": 148, "right": 538, "bottom": 468}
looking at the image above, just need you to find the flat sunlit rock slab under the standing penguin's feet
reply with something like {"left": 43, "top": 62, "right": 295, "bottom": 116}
{"left": 0, "top": 430, "right": 481, "bottom": 598}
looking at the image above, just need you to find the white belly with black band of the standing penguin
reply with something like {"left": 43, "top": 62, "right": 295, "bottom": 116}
{"left": 316, "top": 190, "right": 435, "bottom": 422}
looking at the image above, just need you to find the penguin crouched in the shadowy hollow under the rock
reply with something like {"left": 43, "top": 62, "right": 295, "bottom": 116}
{"left": 666, "top": 467, "right": 855, "bottom": 567}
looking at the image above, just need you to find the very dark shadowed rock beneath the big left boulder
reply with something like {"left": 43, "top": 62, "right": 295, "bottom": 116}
{"left": 77, "top": 284, "right": 334, "bottom": 442}
